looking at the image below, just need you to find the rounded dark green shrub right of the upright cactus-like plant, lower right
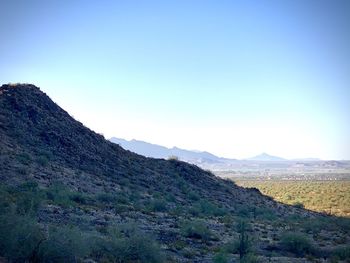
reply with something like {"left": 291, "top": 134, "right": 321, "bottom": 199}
{"left": 280, "top": 232, "right": 312, "bottom": 256}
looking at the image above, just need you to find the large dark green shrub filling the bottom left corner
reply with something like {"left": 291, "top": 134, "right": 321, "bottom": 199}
{"left": 0, "top": 213, "right": 45, "bottom": 262}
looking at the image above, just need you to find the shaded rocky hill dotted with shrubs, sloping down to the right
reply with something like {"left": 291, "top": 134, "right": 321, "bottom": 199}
{"left": 0, "top": 84, "right": 350, "bottom": 262}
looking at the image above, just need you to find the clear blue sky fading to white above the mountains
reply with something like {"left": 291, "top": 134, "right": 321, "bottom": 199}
{"left": 0, "top": 0, "right": 350, "bottom": 159}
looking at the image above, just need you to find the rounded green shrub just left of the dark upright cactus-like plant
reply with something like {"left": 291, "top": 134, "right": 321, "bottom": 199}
{"left": 181, "top": 220, "right": 212, "bottom": 241}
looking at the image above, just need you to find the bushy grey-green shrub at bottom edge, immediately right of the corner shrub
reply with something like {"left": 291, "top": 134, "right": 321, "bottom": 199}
{"left": 38, "top": 226, "right": 90, "bottom": 262}
